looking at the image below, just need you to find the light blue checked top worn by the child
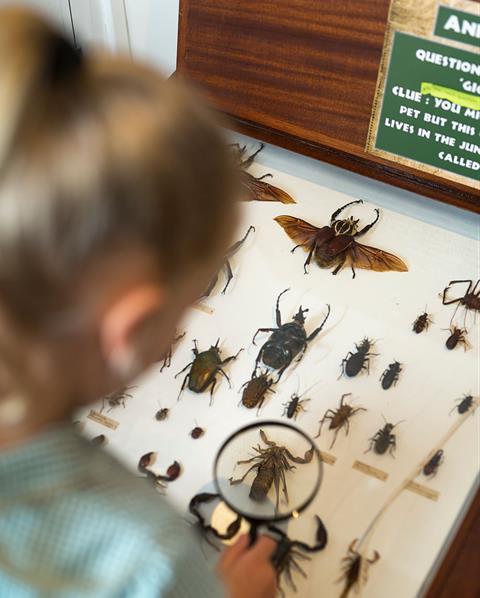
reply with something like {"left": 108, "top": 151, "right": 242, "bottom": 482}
{"left": 0, "top": 425, "right": 224, "bottom": 598}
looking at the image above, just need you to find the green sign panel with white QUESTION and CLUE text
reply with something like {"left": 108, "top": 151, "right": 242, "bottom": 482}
{"left": 375, "top": 32, "right": 480, "bottom": 180}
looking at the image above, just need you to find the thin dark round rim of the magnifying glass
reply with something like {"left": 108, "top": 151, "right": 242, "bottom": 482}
{"left": 213, "top": 419, "right": 323, "bottom": 522}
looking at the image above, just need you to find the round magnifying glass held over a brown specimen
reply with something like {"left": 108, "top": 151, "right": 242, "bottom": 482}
{"left": 213, "top": 420, "right": 323, "bottom": 544}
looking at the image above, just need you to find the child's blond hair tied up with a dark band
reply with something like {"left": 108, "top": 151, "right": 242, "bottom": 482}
{"left": 0, "top": 8, "right": 236, "bottom": 327}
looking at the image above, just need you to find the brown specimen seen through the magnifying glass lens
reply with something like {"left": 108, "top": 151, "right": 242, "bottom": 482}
{"left": 229, "top": 430, "right": 314, "bottom": 513}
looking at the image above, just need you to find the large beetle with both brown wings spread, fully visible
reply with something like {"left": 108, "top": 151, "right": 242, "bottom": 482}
{"left": 274, "top": 199, "right": 408, "bottom": 278}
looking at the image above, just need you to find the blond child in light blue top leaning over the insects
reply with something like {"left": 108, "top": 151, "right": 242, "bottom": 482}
{"left": 0, "top": 8, "right": 275, "bottom": 598}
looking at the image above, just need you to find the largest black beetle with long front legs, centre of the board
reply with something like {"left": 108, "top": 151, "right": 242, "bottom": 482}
{"left": 252, "top": 289, "right": 330, "bottom": 382}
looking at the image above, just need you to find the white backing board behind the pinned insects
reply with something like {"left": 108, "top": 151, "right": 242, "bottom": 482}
{"left": 78, "top": 159, "right": 480, "bottom": 598}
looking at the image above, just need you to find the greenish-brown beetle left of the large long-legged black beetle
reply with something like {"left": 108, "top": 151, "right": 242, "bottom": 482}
{"left": 175, "top": 339, "right": 243, "bottom": 405}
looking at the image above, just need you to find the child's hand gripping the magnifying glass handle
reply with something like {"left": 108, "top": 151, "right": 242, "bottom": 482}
{"left": 217, "top": 535, "right": 277, "bottom": 598}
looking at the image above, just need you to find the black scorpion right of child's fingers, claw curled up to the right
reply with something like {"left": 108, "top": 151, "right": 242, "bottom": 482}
{"left": 267, "top": 515, "right": 328, "bottom": 596}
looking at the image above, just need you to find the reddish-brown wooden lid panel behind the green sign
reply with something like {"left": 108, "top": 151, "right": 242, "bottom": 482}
{"left": 177, "top": 0, "right": 480, "bottom": 212}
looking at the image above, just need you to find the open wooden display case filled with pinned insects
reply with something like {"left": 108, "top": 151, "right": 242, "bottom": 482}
{"left": 80, "top": 0, "right": 480, "bottom": 598}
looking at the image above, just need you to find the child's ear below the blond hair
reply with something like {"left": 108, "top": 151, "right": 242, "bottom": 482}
{"left": 99, "top": 283, "right": 165, "bottom": 379}
